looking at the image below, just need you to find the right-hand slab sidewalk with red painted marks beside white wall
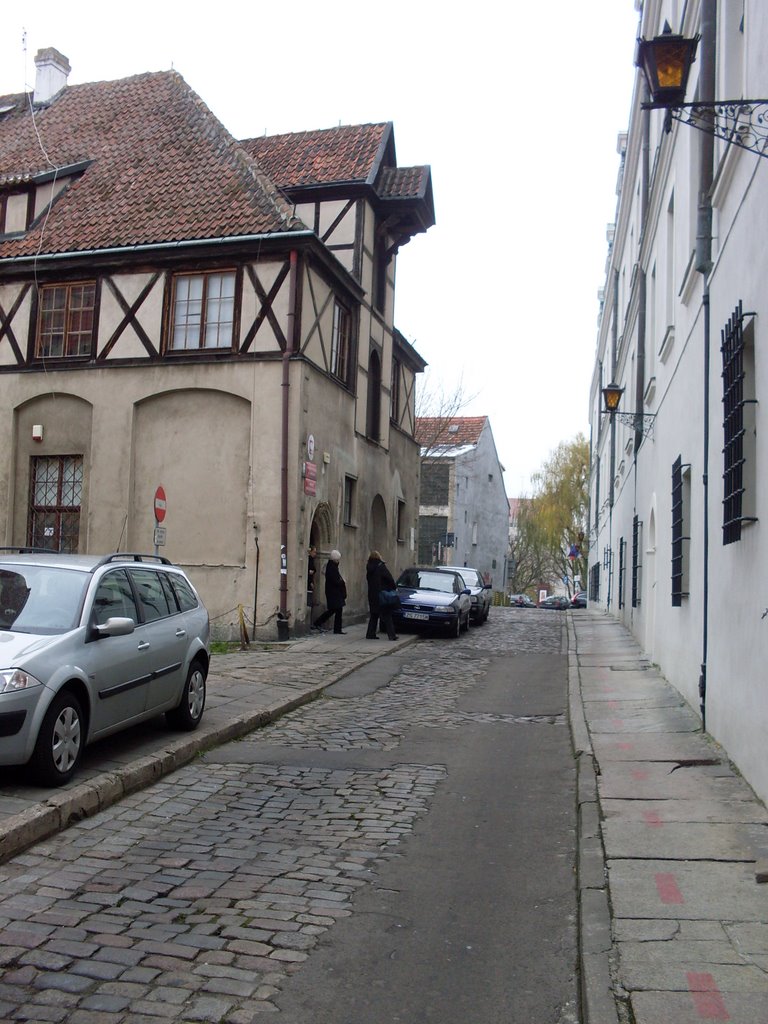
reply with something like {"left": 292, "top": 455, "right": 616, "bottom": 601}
{"left": 568, "top": 611, "right": 768, "bottom": 1024}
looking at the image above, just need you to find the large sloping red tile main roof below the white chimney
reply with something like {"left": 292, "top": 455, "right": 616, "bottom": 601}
{"left": 0, "top": 72, "right": 303, "bottom": 257}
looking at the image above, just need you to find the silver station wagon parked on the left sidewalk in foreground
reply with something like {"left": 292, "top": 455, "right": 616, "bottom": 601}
{"left": 0, "top": 549, "right": 209, "bottom": 785}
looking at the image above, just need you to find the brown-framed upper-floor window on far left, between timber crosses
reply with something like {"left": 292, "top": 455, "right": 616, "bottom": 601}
{"left": 35, "top": 281, "right": 96, "bottom": 359}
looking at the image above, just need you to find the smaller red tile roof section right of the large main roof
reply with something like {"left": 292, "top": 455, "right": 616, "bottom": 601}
{"left": 241, "top": 122, "right": 394, "bottom": 188}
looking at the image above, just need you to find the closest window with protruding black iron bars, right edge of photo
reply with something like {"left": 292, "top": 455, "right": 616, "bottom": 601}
{"left": 720, "top": 300, "right": 756, "bottom": 545}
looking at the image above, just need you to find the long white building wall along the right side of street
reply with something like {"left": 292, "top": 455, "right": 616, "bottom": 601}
{"left": 590, "top": 0, "right": 768, "bottom": 800}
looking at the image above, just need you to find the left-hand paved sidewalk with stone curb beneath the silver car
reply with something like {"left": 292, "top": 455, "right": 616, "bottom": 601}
{"left": 0, "top": 623, "right": 417, "bottom": 862}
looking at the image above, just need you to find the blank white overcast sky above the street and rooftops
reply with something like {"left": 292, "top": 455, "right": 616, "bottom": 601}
{"left": 0, "top": 0, "right": 638, "bottom": 497}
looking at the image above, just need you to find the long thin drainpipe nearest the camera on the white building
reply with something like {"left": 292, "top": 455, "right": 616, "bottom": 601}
{"left": 695, "top": 0, "right": 717, "bottom": 732}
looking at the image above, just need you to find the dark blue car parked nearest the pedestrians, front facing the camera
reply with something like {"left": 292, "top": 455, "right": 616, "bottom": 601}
{"left": 393, "top": 565, "right": 472, "bottom": 637}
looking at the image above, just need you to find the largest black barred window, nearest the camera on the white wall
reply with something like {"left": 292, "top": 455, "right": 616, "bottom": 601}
{"left": 720, "top": 300, "right": 755, "bottom": 545}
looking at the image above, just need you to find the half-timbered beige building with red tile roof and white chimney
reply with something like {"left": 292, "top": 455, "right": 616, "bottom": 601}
{"left": 0, "top": 49, "right": 434, "bottom": 636}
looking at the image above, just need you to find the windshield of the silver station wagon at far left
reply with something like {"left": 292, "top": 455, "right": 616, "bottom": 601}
{"left": 0, "top": 563, "right": 90, "bottom": 635}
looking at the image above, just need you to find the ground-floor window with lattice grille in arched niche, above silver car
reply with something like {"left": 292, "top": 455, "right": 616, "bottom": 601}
{"left": 27, "top": 455, "right": 83, "bottom": 554}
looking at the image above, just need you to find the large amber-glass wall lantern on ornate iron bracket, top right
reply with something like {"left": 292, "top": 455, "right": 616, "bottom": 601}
{"left": 635, "top": 22, "right": 768, "bottom": 157}
